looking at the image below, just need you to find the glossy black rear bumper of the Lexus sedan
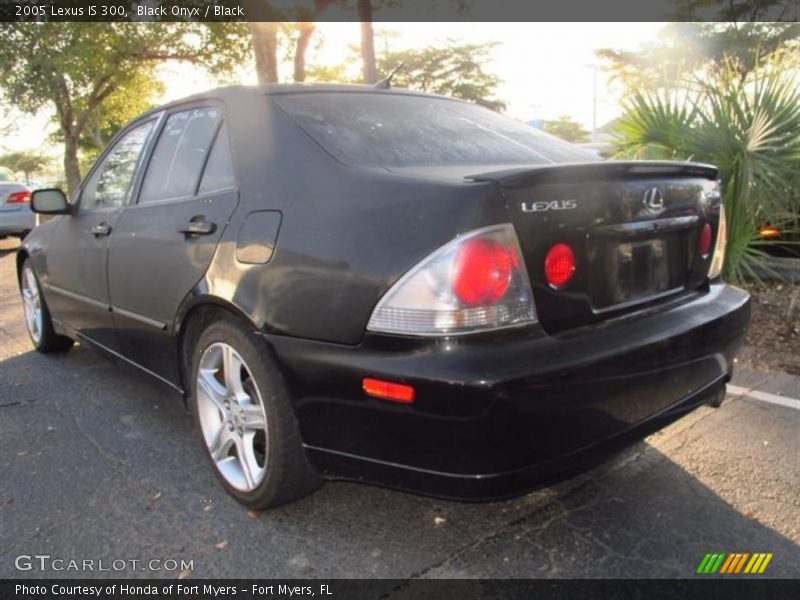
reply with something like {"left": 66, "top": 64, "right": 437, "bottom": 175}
{"left": 268, "top": 284, "right": 750, "bottom": 499}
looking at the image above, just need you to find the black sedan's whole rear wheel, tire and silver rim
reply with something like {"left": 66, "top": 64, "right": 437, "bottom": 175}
{"left": 191, "top": 319, "right": 321, "bottom": 510}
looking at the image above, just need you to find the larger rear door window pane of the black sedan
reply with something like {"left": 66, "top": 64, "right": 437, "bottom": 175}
{"left": 139, "top": 107, "right": 222, "bottom": 203}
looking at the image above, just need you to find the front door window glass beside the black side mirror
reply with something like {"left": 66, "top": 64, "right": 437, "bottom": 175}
{"left": 81, "top": 121, "right": 155, "bottom": 210}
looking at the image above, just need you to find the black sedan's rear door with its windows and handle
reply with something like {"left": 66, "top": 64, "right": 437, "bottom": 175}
{"left": 109, "top": 104, "right": 239, "bottom": 384}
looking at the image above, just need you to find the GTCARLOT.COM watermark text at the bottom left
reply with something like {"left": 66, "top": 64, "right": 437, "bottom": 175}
{"left": 14, "top": 554, "right": 194, "bottom": 572}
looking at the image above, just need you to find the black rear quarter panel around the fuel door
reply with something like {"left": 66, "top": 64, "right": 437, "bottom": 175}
{"left": 191, "top": 95, "right": 508, "bottom": 344}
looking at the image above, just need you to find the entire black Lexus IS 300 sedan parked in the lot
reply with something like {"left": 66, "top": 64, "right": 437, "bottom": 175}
{"left": 18, "top": 85, "right": 750, "bottom": 508}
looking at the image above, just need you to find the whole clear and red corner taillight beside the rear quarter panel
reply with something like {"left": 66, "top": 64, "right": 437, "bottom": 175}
{"left": 367, "top": 224, "right": 536, "bottom": 335}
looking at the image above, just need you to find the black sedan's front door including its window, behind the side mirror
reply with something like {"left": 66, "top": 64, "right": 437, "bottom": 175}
{"left": 45, "top": 119, "right": 156, "bottom": 351}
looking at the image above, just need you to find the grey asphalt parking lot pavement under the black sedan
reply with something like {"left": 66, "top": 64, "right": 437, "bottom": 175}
{"left": 0, "top": 240, "right": 800, "bottom": 578}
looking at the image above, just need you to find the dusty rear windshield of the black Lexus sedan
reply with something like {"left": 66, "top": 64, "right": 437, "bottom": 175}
{"left": 273, "top": 92, "right": 597, "bottom": 167}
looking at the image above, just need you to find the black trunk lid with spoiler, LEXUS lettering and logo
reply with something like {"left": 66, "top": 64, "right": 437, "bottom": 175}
{"left": 469, "top": 161, "right": 720, "bottom": 332}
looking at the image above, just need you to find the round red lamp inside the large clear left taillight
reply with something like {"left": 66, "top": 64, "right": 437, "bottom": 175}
{"left": 453, "top": 238, "right": 514, "bottom": 306}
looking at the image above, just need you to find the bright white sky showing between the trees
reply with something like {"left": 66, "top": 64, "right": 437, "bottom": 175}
{"left": 0, "top": 22, "right": 664, "bottom": 158}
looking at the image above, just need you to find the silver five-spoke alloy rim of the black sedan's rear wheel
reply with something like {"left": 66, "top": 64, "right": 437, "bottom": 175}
{"left": 195, "top": 342, "right": 269, "bottom": 492}
